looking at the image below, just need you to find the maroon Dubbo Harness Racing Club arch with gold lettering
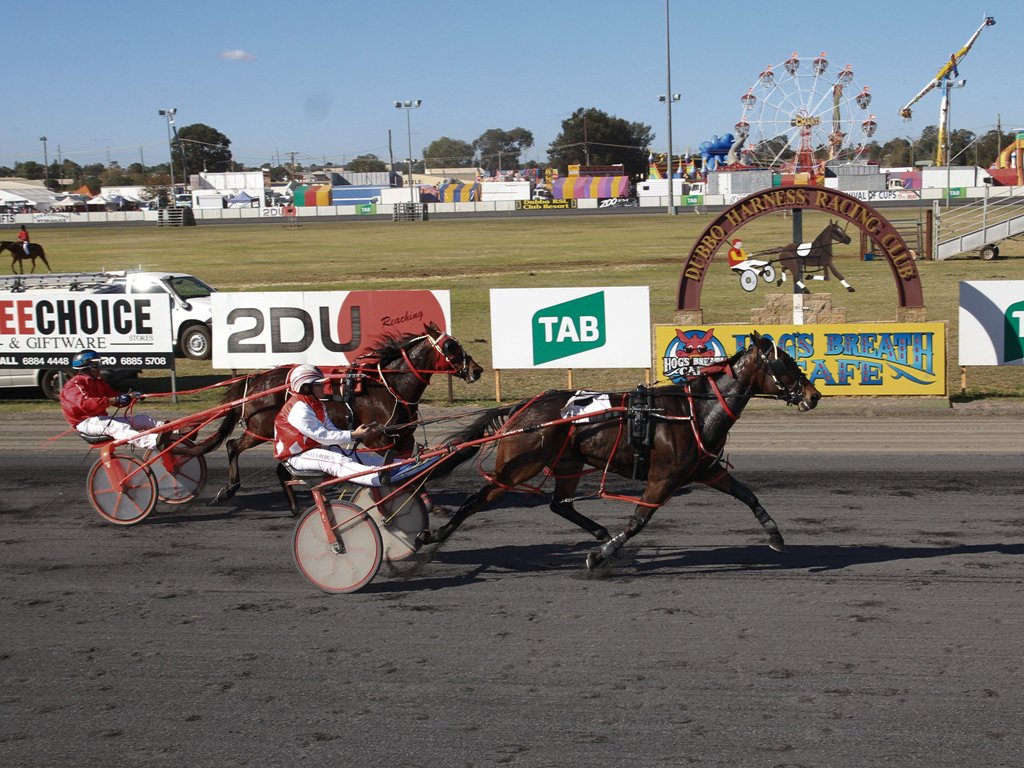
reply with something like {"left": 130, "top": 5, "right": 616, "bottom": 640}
{"left": 676, "top": 186, "right": 925, "bottom": 322}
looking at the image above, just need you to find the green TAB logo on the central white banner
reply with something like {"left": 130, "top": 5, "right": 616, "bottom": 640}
{"left": 531, "top": 291, "right": 606, "bottom": 366}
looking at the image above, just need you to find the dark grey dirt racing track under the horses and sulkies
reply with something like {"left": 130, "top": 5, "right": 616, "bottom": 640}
{"left": 0, "top": 399, "right": 1024, "bottom": 768}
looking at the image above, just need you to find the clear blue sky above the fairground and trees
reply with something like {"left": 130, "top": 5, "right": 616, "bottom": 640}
{"left": 9, "top": 0, "right": 1024, "bottom": 171}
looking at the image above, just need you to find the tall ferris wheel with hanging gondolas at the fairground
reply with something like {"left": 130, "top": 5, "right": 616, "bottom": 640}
{"left": 735, "top": 52, "right": 878, "bottom": 173}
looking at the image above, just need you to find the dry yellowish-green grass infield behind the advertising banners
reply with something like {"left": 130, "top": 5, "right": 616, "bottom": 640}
{"left": 0, "top": 209, "right": 1024, "bottom": 413}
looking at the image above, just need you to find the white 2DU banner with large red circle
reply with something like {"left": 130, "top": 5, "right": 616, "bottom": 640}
{"left": 210, "top": 291, "right": 452, "bottom": 368}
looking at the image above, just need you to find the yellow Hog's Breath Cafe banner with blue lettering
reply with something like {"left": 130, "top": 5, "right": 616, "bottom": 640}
{"left": 654, "top": 323, "right": 946, "bottom": 396}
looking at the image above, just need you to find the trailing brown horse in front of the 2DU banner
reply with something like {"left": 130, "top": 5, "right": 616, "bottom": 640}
{"left": 176, "top": 323, "right": 483, "bottom": 514}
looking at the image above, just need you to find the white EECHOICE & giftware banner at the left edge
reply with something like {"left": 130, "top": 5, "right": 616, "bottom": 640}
{"left": 0, "top": 291, "right": 174, "bottom": 368}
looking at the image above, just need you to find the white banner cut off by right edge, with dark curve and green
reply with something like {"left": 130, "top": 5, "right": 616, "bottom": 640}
{"left": 959, "top": 280, "right": 1024, "bottom": 366}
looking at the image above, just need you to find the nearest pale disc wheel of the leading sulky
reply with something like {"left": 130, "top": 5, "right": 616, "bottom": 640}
{"left": 292, "top": 500, "right": 384, "bottom": 594}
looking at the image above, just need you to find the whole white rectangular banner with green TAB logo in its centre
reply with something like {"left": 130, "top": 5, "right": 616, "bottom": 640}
{"left": 490, "top": 286, "right": 650, "bottom": 369}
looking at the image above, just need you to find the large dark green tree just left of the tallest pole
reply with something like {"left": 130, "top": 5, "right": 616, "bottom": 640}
{"left": 548, "top": 108, "right": 653, "bottom": 176}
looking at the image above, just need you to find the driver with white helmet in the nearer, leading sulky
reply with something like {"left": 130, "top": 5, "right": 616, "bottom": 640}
{"left": 273, "top": 365, "right": 433, "bottom": 485}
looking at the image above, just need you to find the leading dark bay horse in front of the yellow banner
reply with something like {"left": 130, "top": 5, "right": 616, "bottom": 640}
{"left": 417, "top": 331, "right": 820, "bottom": 569}
